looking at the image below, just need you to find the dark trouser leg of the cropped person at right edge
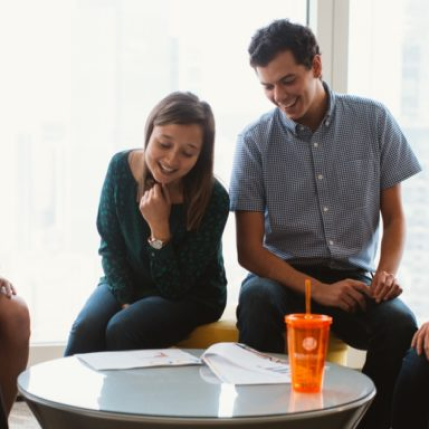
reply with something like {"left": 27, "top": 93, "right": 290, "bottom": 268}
{"left": 392, "top": 349, "right": 429, "bottom": 429}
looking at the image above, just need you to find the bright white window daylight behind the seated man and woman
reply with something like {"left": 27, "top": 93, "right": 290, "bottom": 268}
{"left": 0, "top": 0, "right": 429, "bottom": 344}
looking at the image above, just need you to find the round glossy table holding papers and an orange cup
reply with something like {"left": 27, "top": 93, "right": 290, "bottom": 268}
{"left": 18, "top": 350, "right": 375, "bottom": 429}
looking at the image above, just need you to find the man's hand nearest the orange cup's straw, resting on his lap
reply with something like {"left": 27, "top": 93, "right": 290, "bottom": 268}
{"left": 313, "top": 279, "right": 371, "bottom": 313}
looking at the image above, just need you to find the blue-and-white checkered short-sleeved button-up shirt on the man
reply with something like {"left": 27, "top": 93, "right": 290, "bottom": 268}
{"left": 230, "top": 85, "right": 421, "bottom": 271}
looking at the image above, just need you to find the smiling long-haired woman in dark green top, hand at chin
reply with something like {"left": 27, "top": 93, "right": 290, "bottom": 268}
{"left": 65, "top": 92, "right": 229, "bottom": 356}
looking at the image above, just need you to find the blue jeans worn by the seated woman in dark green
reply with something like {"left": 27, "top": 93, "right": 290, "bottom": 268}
{"left": 64, "top": 283, "right": 221, "bottom": 356}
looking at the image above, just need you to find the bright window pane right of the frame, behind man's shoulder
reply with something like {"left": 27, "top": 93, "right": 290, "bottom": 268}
{"left": 348, "top": 0, "right": 429, "bottom": 321}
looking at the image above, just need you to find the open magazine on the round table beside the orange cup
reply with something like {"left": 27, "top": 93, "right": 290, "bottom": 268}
{"left": 201, "top": 343, "right": 291, "bottom": 384}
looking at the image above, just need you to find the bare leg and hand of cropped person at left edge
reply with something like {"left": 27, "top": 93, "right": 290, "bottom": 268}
{"left": 0, "top": 277, "right": 30, "bottom": 419}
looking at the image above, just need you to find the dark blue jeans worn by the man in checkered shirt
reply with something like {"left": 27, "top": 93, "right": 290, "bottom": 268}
{"left": 237, "top": 267, "right": 417, "bottom": 429}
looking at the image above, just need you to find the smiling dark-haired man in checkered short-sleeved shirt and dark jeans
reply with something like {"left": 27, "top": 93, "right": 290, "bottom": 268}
{"left": 230, "top": 20, "right": 421, "bottom": 429}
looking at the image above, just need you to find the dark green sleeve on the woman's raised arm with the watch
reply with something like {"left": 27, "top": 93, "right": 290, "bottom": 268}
{"left": 148, "top": 182, "right": 229, "bottom": 300}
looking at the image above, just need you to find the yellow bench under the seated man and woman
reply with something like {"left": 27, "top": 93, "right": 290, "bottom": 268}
{"left": 176, "top": 309, "right": 348, "bottom": 365}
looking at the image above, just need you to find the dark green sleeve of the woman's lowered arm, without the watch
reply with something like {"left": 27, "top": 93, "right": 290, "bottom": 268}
{"left": 97, "top": 154, "right": 134, "bottom": 304}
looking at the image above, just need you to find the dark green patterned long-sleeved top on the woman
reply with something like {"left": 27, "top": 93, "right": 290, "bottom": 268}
{"left": 97, "top": 151, "right": 229, "bottom": 311}
